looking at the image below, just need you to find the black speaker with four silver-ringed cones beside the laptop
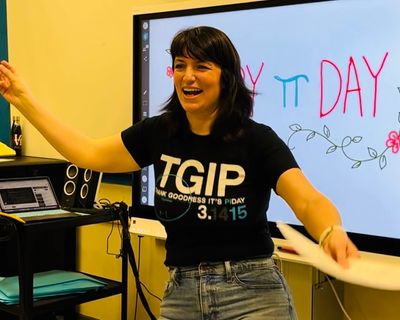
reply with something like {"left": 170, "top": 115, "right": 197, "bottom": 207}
{"left": 60, "top": 163, "right": 101, "bottom": 208}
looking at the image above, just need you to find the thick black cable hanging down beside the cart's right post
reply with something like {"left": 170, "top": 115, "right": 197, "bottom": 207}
{"left": 117, "top": 202, "right": 157, "bottom": 320}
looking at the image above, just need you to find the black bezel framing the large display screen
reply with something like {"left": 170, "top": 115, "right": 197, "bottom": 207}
{"left": 131, "top": 0, "right": 400, "bottom": 256}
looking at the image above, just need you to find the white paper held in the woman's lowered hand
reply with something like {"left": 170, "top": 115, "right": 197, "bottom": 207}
{"left": 277, "top": 222, "right": 400, "bottom": 290}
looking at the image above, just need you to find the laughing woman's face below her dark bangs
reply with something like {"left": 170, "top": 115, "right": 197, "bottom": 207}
{"left": 174, "top": 56, "right": 221, "bottom": 116}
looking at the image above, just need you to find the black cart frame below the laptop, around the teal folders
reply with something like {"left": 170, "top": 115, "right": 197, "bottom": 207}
{"left": 0, "top": 212, "right": 128, "bottom": 320}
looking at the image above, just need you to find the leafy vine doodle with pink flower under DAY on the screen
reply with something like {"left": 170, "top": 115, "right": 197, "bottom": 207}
{"left": 287, "top": 113, "right": 400, "bottom": 170}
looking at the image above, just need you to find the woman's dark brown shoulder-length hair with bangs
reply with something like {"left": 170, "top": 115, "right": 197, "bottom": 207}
{"left": 163, "top": 26, "right": 253, "bottom": 140}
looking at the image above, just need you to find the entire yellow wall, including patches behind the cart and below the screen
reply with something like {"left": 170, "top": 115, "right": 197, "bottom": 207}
{"left": 7, "top": 0, "right": 400, "bottom": 320}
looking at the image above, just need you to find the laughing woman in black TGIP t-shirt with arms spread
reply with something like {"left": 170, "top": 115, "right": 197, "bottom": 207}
{"left": 0, "top": 27, "right": 358, "bottom": 320}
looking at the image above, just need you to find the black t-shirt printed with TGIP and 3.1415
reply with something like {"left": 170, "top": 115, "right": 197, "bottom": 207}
{"left": 121, "top": 115, "right": 298, "bottom": 266}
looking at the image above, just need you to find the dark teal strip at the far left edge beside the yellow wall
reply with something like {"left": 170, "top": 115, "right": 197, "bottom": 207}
{"left": 0, "top": 0, "right": 10, "bottom": 144}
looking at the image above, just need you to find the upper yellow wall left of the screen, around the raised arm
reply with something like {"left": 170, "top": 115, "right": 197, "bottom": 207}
{"left": 7, "top": 0, "right": 256, "bottom": 158}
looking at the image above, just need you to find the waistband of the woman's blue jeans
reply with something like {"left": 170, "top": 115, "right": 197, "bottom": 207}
{"left": 169, "top": 257, "right": 275, "bottom": 277}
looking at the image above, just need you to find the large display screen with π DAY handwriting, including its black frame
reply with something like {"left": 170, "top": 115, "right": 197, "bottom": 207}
{"left": 133, "top": 0, "right": 400, "bottom": 255}
